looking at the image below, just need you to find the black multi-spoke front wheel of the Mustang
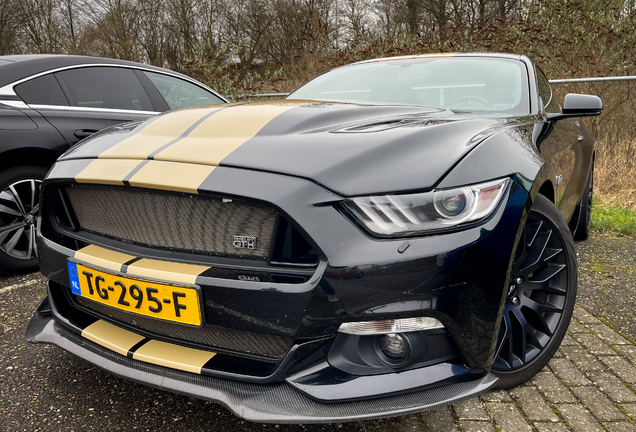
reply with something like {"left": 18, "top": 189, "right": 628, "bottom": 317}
{"left": 492, "top": 195, "right": 577, "bottom": 389}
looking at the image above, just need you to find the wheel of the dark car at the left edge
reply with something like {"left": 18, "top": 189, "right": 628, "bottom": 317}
{"left": 0, "top": 165, "right": 48, "bottom": 274}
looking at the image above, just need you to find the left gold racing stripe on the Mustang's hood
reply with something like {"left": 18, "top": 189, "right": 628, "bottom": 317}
{"left": 99, "top": 108, "right": 220, "bottom": 159}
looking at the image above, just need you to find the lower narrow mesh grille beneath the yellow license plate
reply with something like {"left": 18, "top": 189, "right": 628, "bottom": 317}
{"left": 75, "top": 296, "right": 293, "bottom": 358}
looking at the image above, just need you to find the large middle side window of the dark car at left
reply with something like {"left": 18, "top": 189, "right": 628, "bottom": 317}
{"left": 57, "top": 67, "right": 155, "bottom": 111}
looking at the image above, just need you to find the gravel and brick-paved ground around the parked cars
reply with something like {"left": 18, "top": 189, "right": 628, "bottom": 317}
{"left": 0, "top": 235, "right": 636, "bottom": 432}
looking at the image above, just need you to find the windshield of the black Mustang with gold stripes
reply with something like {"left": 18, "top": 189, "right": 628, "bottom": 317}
{"left": 287, "top": 57, "right": 530, "bottom": 114}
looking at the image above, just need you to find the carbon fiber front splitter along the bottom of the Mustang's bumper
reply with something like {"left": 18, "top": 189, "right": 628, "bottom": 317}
{"left": 26, "top": 302, "right": 497, "bottom": 423}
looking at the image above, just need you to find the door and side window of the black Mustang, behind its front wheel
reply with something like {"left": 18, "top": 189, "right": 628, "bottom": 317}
{"left": 536, "top": 68, "right": 592, "bottom": 220}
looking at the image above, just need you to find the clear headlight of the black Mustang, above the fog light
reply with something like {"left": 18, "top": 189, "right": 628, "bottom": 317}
{"left": 343, "top": 178, "right": 510, "bottom": 237}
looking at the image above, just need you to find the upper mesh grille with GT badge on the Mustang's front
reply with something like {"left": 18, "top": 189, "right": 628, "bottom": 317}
{"left": 66, "top": 185, "right": 276, "bottom": 261}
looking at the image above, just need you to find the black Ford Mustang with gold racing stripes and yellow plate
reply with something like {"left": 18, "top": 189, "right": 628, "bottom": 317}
{"left": 27, "top": 54, "right": 602, "bottom": 422}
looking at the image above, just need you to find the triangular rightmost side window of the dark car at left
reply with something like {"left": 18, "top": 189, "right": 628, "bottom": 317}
{"left": 144, "top": 72, "right": 223, "bottom": 111}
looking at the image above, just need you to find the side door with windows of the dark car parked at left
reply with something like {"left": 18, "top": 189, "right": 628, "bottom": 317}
{"left": 15, "top": 66, "right": 159, "bottom": 145}
